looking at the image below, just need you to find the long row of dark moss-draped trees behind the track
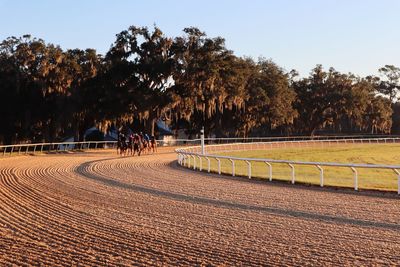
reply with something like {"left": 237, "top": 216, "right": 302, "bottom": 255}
{"left": 0, "top": 26, "right": 400, "bottom": 144}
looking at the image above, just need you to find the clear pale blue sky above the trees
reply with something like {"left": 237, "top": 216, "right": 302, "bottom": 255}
{"left": 0, "top": 0, "right": 400, "bottom": 76}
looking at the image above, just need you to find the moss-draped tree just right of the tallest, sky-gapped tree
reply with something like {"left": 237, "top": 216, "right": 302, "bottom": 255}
{"left": 173, "top": 28, "right": 240, "bottom": 135}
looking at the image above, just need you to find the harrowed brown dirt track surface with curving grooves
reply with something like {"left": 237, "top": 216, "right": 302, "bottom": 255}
{"left": 0, "top": 149, "right": 400, "bottom": 266}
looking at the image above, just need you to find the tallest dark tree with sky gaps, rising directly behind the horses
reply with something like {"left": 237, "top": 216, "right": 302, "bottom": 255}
{"left": 106, "top": 26, "right": 175, "bottom": 134}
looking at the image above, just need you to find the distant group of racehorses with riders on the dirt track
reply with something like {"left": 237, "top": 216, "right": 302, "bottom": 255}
{"left": 117, "top": 134, "right": 157, "bottom": 156}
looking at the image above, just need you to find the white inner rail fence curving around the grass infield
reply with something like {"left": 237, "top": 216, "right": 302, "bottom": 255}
{"left": 175, "top": 138, "right": 400, "bottom": 195}
